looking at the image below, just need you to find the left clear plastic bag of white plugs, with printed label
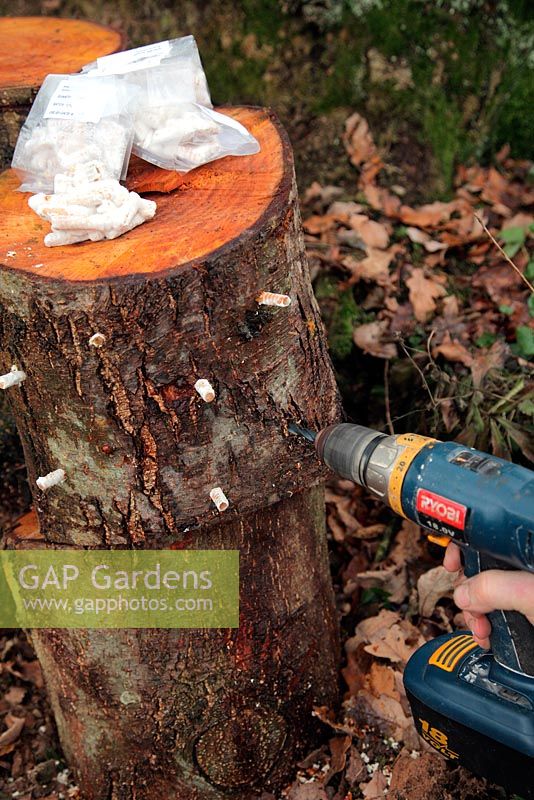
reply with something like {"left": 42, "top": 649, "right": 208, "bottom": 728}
{"left": 12, "top": 75, "right": 139, "bottom": 193}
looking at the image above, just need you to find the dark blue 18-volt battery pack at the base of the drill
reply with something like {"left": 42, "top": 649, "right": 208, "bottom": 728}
{"left": 404, "top": 632, "right": 534, "bottom": 800}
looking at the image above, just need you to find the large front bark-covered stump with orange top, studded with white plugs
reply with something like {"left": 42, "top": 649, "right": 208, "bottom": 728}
{"left": 0, "top": 108, "right": 339, "bottom": 800}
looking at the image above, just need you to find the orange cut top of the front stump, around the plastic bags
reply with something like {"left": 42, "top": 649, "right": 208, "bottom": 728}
{"left": 0, "top": 108, "right": 286, "bottom": 281}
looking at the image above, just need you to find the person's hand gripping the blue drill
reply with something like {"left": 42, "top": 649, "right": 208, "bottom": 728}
{"left": 443, "top": 542, "right": 534, "bottom": 649}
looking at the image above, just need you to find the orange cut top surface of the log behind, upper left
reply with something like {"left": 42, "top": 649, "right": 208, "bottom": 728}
{"left": 0, "top": 17, "right": 122, "bottom": 91}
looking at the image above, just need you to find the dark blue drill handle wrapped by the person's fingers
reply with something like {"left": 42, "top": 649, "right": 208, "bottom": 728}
{"left": 464, "top": 547, "right": 534, "bottom": 677}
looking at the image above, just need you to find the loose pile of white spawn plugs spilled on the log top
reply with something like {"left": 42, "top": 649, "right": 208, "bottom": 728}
{"left": 28, "top": 162, "right": 156, "bottom": 247}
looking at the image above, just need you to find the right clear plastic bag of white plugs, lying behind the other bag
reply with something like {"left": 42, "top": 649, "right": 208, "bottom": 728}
{"left": 84, "top": 36, "right": 260, "bottom": 172}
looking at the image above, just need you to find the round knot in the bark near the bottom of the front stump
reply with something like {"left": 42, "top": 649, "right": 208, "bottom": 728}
{"left": 195, "top": 709, "right": 287, "bottom": 789}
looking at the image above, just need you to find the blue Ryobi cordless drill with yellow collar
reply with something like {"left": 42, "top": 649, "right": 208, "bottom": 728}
{"left": 289, "top": 423, "right": 534, "bottom": 800}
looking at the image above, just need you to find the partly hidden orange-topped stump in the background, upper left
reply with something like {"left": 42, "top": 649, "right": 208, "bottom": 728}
{"left": 0, "top": 17, "right": 122, "bottom": 169}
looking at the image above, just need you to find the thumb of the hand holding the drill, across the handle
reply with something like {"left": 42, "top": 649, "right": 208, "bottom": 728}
{"left": 454, "top": 569, "right": 534, "bottom": 624}
